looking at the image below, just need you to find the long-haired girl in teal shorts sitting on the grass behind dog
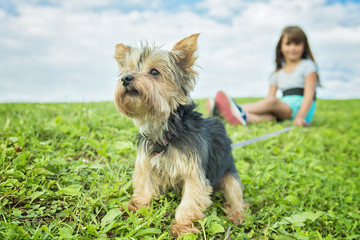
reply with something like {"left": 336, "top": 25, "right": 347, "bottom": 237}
{"left": 206, "top": 26, "right": 319, "bottom": 126}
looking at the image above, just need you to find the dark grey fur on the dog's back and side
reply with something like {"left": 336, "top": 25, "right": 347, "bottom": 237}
{"left": 171, "top": 103, "right": 237, "bottom": 186}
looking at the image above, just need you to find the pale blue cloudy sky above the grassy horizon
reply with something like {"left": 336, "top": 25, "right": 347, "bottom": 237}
{"left": 0, "top": 0, "right": 360, "bottom": 102}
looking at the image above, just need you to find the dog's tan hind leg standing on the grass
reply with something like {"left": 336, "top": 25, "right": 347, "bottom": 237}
{"left": 220, "top": 172, "right": 248, "bottom": 225}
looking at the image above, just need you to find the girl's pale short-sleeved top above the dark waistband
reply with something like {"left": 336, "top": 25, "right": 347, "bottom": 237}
{"left": 270, "top": 59, "right": 317, "bottom": 91}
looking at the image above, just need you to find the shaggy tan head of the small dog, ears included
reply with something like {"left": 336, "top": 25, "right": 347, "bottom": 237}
{"left": 115, "top": 34, "right": 199, "bottom": 122}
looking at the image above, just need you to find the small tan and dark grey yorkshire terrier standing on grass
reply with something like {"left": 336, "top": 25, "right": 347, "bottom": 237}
{"left": 115, "top": 34, "right": 247, "bottom": 236}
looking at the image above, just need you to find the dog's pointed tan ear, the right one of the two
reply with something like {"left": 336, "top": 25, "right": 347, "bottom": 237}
{"left": 172, "top": 33, "right": 200, "bottom": 69}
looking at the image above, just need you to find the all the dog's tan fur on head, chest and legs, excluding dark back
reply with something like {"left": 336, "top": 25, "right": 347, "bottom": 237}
{"left": 115, "top": 34, "right": 245, "bottom": 236}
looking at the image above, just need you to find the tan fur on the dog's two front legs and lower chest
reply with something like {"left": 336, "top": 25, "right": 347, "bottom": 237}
{"left": 127, "top": 138, "right": 212, "bottom": 236}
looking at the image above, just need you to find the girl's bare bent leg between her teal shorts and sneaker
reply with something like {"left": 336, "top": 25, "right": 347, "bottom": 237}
{"left": 241, "top": 97, "right": 292, "bottom": 122}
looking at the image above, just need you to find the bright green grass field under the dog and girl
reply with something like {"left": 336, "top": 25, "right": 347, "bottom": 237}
{"left": 0, "top": 99, "right": 360, "bottom": 239}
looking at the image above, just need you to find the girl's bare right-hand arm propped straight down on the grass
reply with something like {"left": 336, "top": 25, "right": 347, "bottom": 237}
{"left": 293, "top": 72, "right": 317, "bottom": 126}
